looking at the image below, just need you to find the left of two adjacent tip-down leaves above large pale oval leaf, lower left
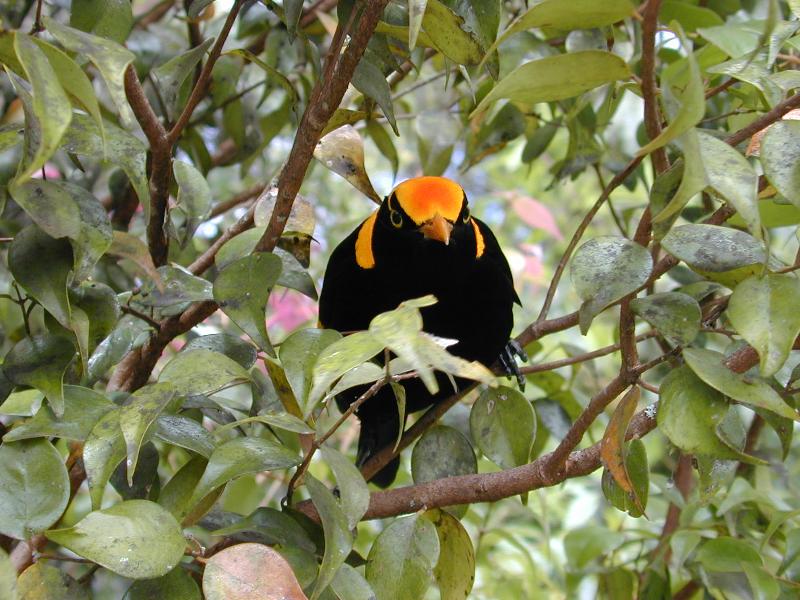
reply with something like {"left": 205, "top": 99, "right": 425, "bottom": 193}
{"left": 83, "top": 409, "right": 125, "bottom": 509}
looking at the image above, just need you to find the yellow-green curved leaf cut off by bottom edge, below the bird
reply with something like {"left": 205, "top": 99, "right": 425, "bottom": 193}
{"left": 423, "top": 509, "right": 475, "bottom": 600}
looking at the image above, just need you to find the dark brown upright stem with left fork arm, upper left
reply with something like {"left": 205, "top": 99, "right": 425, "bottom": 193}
{"left": 125, "top": 64, "right": 172, "bottom": 267}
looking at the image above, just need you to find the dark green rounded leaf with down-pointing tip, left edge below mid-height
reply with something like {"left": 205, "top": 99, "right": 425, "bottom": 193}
{"left": 3, "top": 334, "right": 75, "bottom": 417}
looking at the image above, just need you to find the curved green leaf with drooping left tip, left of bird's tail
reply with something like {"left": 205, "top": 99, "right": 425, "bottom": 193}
{"left": 189, "top": 437, "right": 300, "bottom": 505}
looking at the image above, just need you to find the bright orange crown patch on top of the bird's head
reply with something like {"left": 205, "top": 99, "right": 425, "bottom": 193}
{"left": 394, "top": 177, "right": 464, "bottom": 225}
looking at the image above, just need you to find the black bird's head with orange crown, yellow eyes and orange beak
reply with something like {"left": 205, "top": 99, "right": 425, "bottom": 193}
{"left": 383, "top": 177, "right": 470, "bottom": 245}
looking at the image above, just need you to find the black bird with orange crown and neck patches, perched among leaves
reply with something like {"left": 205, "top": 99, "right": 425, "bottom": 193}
{"left": 319, "top": 176, "right": 527, "bottom": 488}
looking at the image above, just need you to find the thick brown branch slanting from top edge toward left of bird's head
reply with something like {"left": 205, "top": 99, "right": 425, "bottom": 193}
{"left": 252, "top": 0, "right": 388, "bottom": 251}
